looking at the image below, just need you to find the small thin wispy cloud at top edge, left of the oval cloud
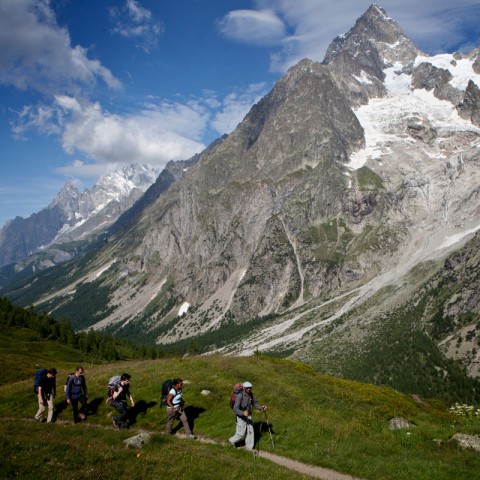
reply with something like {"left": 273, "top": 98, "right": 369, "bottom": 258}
{"left": 110, "top": 0, "right": 163, "bottom": 53}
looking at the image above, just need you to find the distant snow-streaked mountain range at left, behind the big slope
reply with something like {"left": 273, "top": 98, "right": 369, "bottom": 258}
{"left": 0, "top": 165, "right": 158, "bottom": 270}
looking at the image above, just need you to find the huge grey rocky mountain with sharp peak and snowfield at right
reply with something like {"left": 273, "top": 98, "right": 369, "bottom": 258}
{"left": 0, "top": 5, "right": 480, "bottom": 392}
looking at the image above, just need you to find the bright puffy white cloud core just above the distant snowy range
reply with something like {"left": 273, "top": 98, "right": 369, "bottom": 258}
{"left": 57, "top": 97, "right": 207, "bottom": 166}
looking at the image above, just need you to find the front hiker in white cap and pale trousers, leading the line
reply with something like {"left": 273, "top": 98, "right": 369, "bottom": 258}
{"left": 228, "top": 382, "right": 267, "bottom": 450}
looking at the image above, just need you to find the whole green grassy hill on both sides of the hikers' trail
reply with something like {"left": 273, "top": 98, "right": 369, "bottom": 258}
{"left": 0, "top": 356, "right": 480, "bottom": 480}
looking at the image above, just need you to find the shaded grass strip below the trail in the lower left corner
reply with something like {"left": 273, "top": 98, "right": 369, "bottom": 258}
{"left": 0, "top": 420, "right": 305, "bottom": 480}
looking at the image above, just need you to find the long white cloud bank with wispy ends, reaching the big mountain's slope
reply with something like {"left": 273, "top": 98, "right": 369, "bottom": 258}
{"left": 13, "top": 79, "right": 267, "bottom": 177}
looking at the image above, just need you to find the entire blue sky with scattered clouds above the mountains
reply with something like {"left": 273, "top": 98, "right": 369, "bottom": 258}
{"left": 0, "top": 0, "right": 480, "bottom": 227}
